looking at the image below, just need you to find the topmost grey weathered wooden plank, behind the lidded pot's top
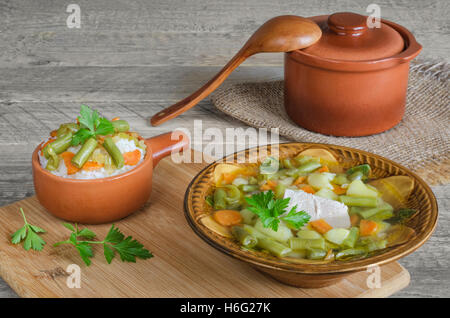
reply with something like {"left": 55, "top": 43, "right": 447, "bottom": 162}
{"left": 0, "top": 0, "right": 450, "bottom": 67}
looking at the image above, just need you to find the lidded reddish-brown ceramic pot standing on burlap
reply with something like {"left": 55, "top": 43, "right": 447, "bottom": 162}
{"left": 284, "top": 12, "right": 422, "bottom": 136}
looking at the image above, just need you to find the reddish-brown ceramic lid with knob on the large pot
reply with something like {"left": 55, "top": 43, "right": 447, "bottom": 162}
{"left": 302, "top": 12, "right": 405, "bottom": 61}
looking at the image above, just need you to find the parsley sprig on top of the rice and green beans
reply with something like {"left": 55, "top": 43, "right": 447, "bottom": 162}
{"left": 71, "top": 105, "right": 114, "bottom": 146}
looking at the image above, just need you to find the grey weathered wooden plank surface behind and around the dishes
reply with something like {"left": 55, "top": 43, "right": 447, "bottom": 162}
{"left": 0, "top": 0, "right": 450, "bottom": 297}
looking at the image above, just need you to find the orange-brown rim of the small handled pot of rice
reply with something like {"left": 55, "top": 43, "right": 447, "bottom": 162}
{"left": 31, "top": 139, "right": 153, "bottom": 185}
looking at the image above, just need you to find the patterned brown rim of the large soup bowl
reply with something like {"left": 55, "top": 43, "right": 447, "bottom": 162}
{"left": 183, "top": 142, "right": 439, "bottom": 275}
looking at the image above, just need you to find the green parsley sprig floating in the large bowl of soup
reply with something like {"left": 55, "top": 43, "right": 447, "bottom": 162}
{"left": 245, "top": 190, "right": 311, "bottom": 231}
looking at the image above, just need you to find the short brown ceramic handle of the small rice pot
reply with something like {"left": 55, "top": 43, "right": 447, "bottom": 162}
{"left": 146, "top": 131, "right": 189, "bottom": 167}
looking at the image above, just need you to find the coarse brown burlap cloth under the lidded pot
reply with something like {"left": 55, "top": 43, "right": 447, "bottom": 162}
{"left": 212, "top": 60, "right": 450, "bottom": 184}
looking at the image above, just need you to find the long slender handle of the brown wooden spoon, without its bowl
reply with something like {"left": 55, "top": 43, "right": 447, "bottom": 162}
{"left": 150, "top": 46, "right": 252, "bottom": 126}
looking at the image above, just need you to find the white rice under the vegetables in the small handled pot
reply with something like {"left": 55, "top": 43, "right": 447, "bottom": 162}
{"left": 39, "top": 138, "right": 145, "bottom": 179}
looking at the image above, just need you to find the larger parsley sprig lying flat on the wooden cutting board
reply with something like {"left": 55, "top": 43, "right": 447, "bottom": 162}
{"left": 53, "top": 223, "right": 153, "bottom": 266}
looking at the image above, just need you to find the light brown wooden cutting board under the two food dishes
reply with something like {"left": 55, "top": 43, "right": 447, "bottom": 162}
{"left": 0, "top": 153, "right": 409, "bottom": 297}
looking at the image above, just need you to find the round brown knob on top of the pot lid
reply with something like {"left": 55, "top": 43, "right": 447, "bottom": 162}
{"left": 327, "top": 12, "right": 367, "bottom": 36}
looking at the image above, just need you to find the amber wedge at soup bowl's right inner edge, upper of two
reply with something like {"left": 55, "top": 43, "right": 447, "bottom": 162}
{"left": 369, "top": 176, "right": 414, "bottom": 209}
